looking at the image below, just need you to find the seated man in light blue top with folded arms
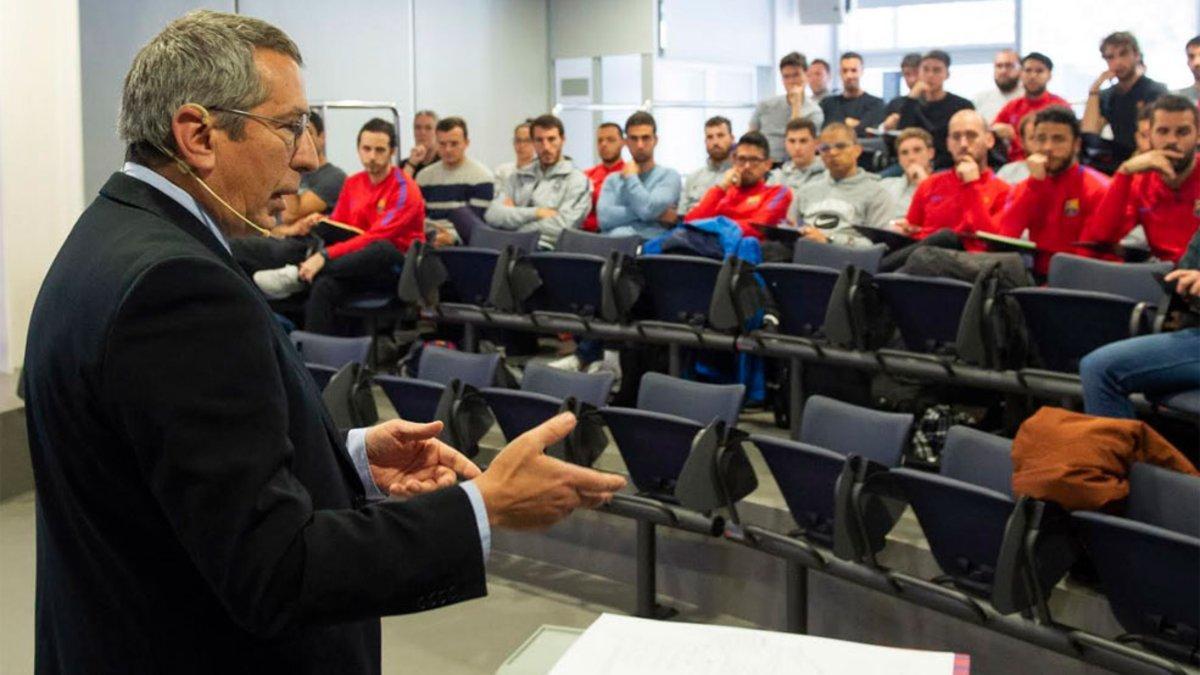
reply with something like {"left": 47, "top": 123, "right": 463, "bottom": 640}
{"left": 596, "top": 112, "right": 680, "bottom": 239}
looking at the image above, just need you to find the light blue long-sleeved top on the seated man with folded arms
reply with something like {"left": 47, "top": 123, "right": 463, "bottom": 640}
{"left": 596, "top": 166, "right": 683, "bottom": 239}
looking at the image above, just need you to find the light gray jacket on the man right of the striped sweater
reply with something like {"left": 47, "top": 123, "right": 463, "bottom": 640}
{"left": 484, "top": 159, "right": 592, "bottom": 249}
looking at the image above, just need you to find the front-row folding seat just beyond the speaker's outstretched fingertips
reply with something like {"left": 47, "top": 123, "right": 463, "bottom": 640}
{"left": 600, "top": 372, "right": 745, "bottom": 502}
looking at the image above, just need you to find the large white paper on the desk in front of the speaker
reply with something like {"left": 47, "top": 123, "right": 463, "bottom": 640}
{"left": 551, "top": 614, "right": 954, "bottom": 675}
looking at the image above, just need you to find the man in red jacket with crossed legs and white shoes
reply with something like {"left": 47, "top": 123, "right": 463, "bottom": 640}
{"left": 254, "top": 118, "right": 425, "bottom": 334}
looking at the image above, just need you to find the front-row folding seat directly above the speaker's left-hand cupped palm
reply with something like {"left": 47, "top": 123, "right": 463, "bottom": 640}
{"left": 376, "top": 346, "right": 500, "bottom": 422}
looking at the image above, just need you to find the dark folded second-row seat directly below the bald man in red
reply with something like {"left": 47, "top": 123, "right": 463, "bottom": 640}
{"left": 875, "top": 274, "right": 971, "bottom": 353}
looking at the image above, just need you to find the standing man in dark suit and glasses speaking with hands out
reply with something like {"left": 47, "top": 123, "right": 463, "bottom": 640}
{"left": 24, "top": 12, "right": 624, "bottom": 673}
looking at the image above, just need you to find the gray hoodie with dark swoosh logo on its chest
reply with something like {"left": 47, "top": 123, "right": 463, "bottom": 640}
{"left": 787, "top": 169, "right": 895, "bottom": 246}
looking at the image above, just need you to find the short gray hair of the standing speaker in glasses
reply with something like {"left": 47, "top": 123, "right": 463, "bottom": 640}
{"left": 118, "top": 10, "right": 304, "bottom": 160}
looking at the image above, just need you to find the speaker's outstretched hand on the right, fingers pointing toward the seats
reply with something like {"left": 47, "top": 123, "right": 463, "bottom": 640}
{"left": 475, "top": 413, "right": 625, "bottom": 530}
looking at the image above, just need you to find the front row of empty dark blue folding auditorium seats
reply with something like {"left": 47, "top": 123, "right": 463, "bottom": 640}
{"left": 290, "top": 335, "right": 1200, "bottom": 673}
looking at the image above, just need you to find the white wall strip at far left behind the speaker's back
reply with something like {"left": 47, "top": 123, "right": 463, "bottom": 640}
{"left": 0, "top": 0, "right": 83, "bottom": 371}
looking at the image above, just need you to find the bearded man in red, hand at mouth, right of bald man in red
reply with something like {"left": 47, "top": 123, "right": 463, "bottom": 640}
{"left": 996, "top": 106, "right": 1109, "bottom": 276}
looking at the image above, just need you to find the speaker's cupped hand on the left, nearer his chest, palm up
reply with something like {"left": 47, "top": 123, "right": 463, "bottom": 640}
{"left": 366, "top": 419, "right": 480, "bottom": 497}
